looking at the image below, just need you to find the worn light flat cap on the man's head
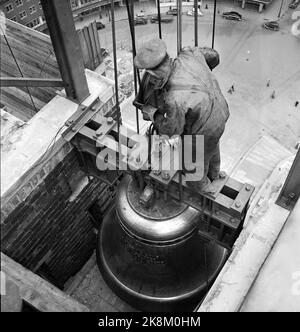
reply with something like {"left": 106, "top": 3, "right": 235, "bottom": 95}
{"left": 133, "top": 38, "right": 167, "bottom": 69}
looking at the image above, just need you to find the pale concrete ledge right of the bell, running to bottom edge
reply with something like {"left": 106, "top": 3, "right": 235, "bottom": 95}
{"left": 198, "top": 158, "right": 292, "bottom": 312}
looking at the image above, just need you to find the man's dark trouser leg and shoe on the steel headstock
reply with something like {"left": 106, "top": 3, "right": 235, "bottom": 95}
{"left": 186, "top": 136, "right": 221, "bottom": 193}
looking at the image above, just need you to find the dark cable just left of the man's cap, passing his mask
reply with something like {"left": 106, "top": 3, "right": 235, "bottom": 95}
{"left": 125, "top": 0, "right": 141, "bottom": 134}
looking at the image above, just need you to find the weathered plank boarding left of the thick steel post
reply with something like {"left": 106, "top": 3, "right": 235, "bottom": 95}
{"left": 0, "top": 20, "right": 61, "bottom": 120}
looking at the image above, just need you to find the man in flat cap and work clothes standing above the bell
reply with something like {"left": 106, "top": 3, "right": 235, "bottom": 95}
{"left": 134, "top": 39, "right": 229, "bottom": 193}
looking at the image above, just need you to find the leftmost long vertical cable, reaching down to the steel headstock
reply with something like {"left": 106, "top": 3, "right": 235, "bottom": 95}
{"left": 110, "top": 0, "right": 121, "bottom": 157}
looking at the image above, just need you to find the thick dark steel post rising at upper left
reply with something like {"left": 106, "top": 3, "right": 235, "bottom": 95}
{"left": 41, "top": 0, "right": 89, "bottom": 103}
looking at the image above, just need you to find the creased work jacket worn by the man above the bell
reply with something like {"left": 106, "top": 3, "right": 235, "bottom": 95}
{"left": 138, "top": 47, "right": 229, "bottom": 144}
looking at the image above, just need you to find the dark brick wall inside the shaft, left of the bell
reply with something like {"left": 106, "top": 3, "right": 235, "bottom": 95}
{"left": 1, "top": 146, "right": 115, "bottom": 287}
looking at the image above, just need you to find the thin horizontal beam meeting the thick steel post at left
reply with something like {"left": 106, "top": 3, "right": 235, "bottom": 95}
{"left": 0, "top": 77, "right": 64, "bottom": 88}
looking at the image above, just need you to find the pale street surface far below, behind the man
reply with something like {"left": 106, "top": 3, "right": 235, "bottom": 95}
{"left": 75, "top": 0, "right": 300, "bottom": 172}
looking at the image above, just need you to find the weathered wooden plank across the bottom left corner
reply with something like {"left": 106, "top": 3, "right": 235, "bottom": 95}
{"left": 1, "top": 253, "right": 89, "bottom": 312}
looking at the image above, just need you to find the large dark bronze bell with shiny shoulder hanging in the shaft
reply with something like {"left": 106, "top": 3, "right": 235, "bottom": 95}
{"left": 97, "top": 176, "right": 227, "bottom": 311}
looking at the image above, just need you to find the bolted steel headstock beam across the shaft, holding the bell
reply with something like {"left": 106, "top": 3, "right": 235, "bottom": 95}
{"left": 67, "top": 113, "right": 254, "bottom": 248}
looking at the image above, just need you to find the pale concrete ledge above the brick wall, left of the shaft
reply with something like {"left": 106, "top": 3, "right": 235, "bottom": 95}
{"left": 1, "top": 70, "right": 114, "bottom": 206}
